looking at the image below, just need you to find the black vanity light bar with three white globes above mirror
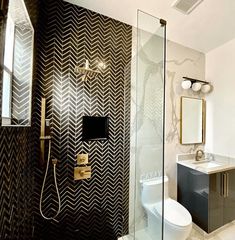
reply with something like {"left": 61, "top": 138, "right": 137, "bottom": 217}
{"left": 181, "top": 77, "right": 212, "bottom": 93}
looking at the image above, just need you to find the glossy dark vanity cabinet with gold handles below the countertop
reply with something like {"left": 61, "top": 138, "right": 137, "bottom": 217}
{"left": 177, "top": 164, "right": 235, "bottom": 233}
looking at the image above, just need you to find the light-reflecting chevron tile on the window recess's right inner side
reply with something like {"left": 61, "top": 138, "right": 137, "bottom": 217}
{"left": 11, "top": 25, "right": 33, "bottom": 125}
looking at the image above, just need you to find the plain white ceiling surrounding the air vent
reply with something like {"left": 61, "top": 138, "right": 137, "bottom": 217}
{"left": 66, "top": 0, "right": 235, "bottom": 53}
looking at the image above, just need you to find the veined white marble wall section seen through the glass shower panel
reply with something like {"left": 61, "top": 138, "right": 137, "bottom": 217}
{"left": 129, "top": 25, "right": 163, "bottom": 232}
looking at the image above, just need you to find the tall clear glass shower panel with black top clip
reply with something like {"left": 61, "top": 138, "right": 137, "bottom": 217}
{"left": 133, "top": 11, "right": 166, "bottom": 240}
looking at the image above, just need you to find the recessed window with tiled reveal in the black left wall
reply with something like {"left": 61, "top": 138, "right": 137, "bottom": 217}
{"left": 1, "top": 0, "right": 34, "bottom": 126}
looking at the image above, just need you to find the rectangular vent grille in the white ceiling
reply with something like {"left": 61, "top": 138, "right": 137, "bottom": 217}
{"left": 172, "top": 0, "right": 203, "bottom": 14}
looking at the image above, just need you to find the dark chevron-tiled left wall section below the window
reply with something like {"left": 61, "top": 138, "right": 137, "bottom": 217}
{"left": 0, "top": 128, "right": 33, "bottom": 239}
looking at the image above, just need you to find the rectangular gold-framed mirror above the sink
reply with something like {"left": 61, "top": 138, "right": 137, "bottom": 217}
{"left": 180, "top": 97, "right": 205, "bottom": 144}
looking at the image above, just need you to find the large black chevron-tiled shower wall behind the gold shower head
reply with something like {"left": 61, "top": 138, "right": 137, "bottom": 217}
{"left": 33, "top": 0, "right": 132, "bottom": 240}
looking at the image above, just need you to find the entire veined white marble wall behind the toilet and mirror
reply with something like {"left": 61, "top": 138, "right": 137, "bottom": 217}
{"left": 129, "top": 26, "right": 205, "bottom": 233}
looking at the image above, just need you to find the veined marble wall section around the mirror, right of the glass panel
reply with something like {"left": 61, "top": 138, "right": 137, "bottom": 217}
{"left": 165, "top": 41, "right": 205, "bottom": 199}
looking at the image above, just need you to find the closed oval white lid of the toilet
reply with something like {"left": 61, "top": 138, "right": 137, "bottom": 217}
{"left": 154, "top": 199, "right": 192, "bottom": 227}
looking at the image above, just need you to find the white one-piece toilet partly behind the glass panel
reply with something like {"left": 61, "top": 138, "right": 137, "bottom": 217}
{"left": 141, "top": 176, "right": 192, "bottom": 240}
